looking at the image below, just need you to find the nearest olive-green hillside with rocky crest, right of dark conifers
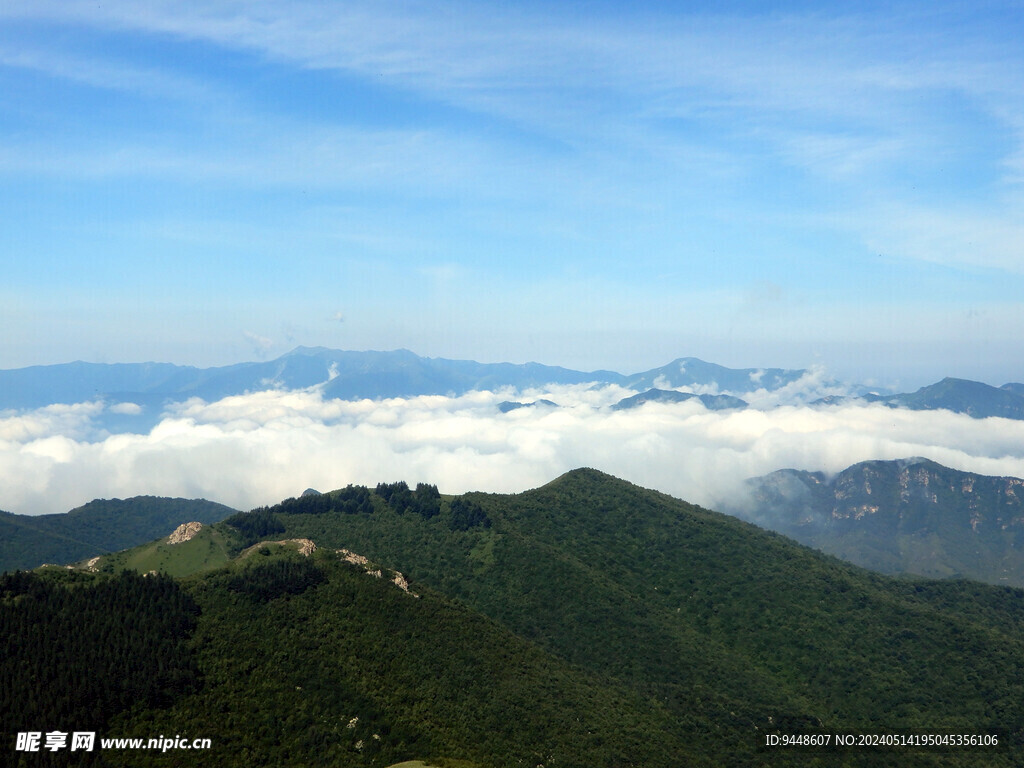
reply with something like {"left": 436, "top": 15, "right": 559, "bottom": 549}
{"left": 105, "top": 551, "right": 709, "bottom": 766}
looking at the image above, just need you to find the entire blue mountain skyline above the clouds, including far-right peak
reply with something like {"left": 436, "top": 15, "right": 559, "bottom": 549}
{"left": 0, "top": 347, "right": 1024, "bottom": 423}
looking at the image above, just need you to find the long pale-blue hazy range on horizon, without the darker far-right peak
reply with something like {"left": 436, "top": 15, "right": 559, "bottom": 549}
{"left": 0, "top": 347, "right": 806, "bottom": 415}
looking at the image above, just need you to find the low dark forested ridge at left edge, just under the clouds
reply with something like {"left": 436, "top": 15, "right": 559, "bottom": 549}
{"left": 0, "top": 496, "right": 236, "bottom": 572}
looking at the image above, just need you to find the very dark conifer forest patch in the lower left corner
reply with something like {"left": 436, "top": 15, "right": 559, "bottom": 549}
{"left": 0, "top": 569, "right": 200, "bottom": 766}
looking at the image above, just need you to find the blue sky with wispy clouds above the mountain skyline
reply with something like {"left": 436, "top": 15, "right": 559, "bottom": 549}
{"left": 0, "top": 0, "right": 1024, "bottom": 387}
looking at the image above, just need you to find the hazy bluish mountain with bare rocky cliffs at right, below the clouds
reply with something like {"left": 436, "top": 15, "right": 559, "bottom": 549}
{"left": 730, "top": 459, "right": 1024, "bottom": 587}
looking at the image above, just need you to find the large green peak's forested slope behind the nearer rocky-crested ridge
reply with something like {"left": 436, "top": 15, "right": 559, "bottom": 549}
{"left": 249, "top": 470, "right": 1024, "bottom": 750}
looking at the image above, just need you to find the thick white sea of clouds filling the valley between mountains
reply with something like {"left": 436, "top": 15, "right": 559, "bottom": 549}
{"left": 0, "top": 385, "right": 1024, "bottom": 514}
